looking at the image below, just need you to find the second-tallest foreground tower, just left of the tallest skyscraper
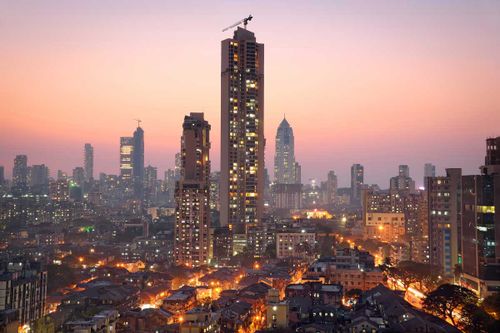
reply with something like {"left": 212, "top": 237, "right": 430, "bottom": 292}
{"left": 174, "top": 113, "right": 210, "bottom": 267}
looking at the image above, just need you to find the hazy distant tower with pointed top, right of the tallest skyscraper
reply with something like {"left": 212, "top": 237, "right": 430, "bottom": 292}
{"left": 274, "top": 118, "right": 296, "bottom": 184}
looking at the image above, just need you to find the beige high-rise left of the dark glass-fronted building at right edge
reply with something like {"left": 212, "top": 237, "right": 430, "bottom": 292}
{"left": 425, "top": 168, "right": 462, "bottom": 276}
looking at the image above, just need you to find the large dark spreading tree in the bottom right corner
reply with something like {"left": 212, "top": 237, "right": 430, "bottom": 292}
{"left": 423, "top": 283, "right": 478, "bottom": 326}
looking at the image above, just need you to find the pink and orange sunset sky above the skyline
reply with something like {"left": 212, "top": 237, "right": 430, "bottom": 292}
{"left": 0, "top": 0, "right": 500, "bottom": 188}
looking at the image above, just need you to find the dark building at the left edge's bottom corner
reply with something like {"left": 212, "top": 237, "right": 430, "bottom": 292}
{"left": 0, "top": 262, "right": 47, "bottom": 326}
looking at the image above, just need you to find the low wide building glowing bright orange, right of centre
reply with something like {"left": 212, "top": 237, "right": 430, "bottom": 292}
{"left": 364, "top": 213, "right": 405, "bottom": 243}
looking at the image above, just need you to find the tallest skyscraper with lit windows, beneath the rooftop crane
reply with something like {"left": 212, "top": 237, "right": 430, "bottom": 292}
{"left": 220, "top": 27, "right": 265, "bottom": 253}
